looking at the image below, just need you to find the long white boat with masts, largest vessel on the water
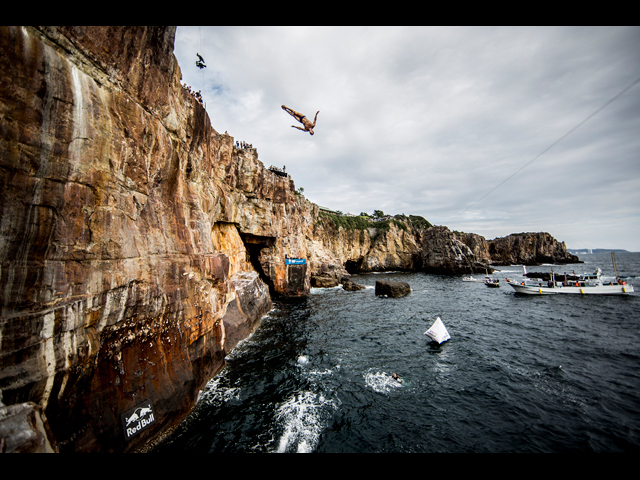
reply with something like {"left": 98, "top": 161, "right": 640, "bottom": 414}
{"left": 507, "top": 268, "right": 633, "bottom": 295}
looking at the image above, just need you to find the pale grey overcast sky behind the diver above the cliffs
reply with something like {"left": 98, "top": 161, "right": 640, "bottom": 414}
{"left": 175, "top": 26, "right": 640, "bottom": 251}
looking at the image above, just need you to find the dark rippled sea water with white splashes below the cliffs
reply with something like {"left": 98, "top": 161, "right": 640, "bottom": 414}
{"left": 153, "top": 253, "right": 640, "bottom": 453}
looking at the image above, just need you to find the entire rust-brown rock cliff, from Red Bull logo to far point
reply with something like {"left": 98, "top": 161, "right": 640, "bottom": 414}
{"left": 0, "top": 27, "right": 577, "bottom": 452}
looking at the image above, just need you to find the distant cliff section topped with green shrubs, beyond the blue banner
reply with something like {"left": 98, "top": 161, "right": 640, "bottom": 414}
{"left": 306, "top": 214, "right": 579, "bottom": 280}
